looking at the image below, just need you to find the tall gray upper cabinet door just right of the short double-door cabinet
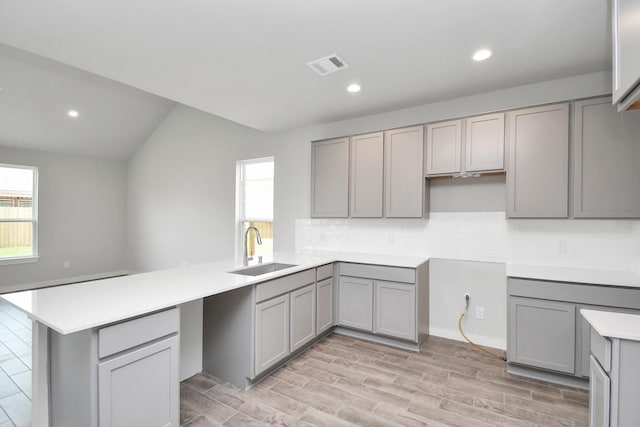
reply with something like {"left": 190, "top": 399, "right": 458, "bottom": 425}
{"left": 507, "top": 104, "right": 569, "bottom": 218}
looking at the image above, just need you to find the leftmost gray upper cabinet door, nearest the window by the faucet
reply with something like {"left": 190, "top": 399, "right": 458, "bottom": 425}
{"left": 311, "top": 138, "right": 349, "bottom": 218}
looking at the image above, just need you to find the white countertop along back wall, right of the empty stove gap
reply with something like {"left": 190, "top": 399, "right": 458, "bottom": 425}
{"left": 507, "top": 264, "right": 640, "bottom": 288}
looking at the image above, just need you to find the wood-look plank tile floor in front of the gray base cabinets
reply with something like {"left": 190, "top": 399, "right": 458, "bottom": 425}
{"left": 180, "top": 335, "right": 589, "bottom": 427}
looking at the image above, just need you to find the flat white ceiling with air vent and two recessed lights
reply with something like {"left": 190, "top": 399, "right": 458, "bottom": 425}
{"left": 0, "top": 0, "right": 611, "bottom": 158}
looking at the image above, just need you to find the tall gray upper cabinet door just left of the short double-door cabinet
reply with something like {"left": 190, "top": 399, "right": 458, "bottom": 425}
{"left": 384, "top": 126, "right": 425, "bottom": 218}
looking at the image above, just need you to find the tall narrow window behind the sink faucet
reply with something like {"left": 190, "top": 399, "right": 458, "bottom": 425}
{"left": 236, "top": 157, "right": 274, "bottom": 256}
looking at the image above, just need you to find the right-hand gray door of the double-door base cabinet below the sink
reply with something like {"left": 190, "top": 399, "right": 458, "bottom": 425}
{"left": 289, "top": 283, "right": 316, "bottom": 352}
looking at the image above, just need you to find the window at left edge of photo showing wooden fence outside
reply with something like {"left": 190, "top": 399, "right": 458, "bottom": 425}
{"left": 0, "top": 164, "right": 38, "bottom": 264}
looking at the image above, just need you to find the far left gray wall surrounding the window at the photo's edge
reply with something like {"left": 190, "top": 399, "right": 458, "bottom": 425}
{"left": 0, "top": 146, "right": 126, "bottom": 292}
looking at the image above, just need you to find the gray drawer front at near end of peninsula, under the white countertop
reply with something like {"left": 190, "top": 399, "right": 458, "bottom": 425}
{"left": 98, "top": 308, "right": 180, "bottom": 358}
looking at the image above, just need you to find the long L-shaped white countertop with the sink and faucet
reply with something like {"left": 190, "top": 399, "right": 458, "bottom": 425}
{"left": 0, "top": 252, "right": 427, "bottom": 334}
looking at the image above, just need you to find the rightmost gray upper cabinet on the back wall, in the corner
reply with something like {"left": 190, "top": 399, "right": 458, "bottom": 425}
{"left": 573, "top": 98, "right": 640, "bottom": 218}
